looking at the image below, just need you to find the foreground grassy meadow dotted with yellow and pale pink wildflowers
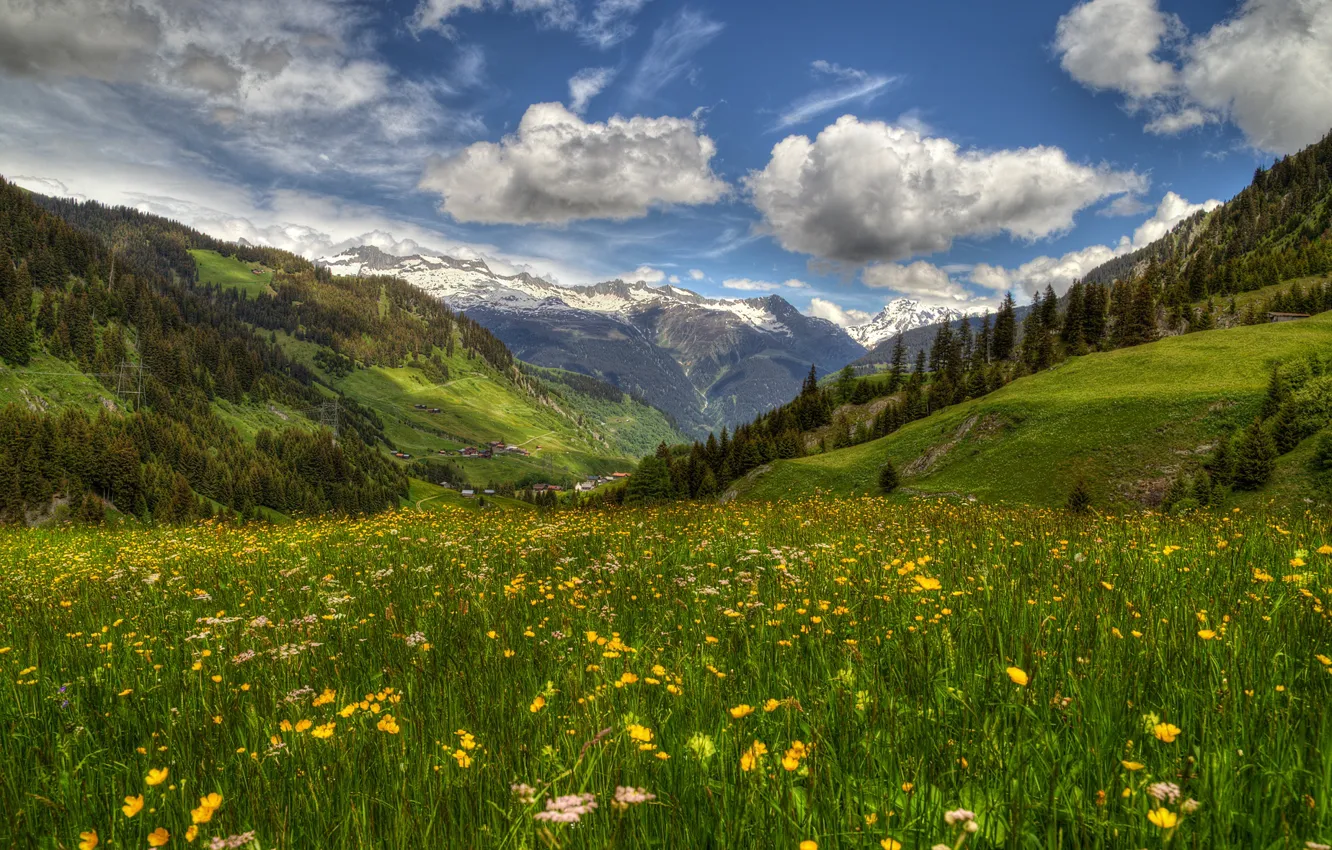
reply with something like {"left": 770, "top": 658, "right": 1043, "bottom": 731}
{"left": 0, "top": 498, "right": 1332, "bottom": 850}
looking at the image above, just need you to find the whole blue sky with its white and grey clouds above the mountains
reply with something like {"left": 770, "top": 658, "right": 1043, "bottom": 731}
{"left": 0, "top": 0, "right": 1332, "bottom": 325}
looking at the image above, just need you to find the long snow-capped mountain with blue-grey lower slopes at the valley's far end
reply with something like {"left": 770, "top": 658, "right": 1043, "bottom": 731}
{"left": 320, "top": 246, "right": 864, "bottom": 433}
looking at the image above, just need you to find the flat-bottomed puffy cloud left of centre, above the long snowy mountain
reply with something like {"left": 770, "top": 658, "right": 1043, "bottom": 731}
{"left": 420, "top": 104, "right": 727, "bottom": 224}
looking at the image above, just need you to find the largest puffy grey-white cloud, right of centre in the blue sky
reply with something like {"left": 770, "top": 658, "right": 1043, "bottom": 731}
{"left": 745, "top": 116, "right": 1147, "bottom": 264}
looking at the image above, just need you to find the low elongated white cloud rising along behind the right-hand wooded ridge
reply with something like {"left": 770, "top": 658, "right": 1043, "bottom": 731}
{"left": 968, "top": 192, "right": 1221, "bottom": 296}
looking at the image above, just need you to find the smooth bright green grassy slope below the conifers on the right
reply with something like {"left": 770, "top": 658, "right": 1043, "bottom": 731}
{"left": 738, "top": 314, "right": 1332, "bottom": 505}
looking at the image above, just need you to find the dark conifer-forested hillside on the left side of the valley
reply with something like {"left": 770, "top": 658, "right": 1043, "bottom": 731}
{"left": 0, "top": 181, "right": 674, "bottom": 522}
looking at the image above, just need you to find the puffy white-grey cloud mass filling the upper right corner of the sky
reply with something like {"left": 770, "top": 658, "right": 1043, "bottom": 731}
{"left": 1055, "top": 0, "right": 1332, "bottom": 153}
